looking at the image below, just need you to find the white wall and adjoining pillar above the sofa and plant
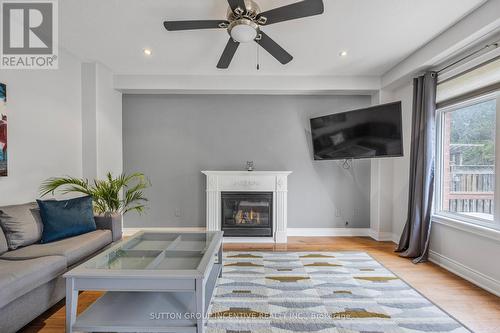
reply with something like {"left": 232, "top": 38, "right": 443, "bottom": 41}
{"left": 0, "top": 54, "right": 122, "bottom": 206}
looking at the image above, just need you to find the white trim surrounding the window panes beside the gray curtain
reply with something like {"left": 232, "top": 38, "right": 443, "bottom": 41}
{"left": 432, "top": 92, "right": 500, "bottom": 228}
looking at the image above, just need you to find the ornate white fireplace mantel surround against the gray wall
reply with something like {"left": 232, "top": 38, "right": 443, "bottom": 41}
{"left": 202, "top": 171, "right": 292, "bottom": 243}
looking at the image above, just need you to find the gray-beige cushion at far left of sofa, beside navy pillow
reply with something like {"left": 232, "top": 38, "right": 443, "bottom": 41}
{"left": 0, "top": 203, "right": 43, "bottom": 250}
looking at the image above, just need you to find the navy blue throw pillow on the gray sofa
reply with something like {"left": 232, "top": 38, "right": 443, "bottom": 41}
{"left": 36, "top": 196, "right": 96, "bottom": 243}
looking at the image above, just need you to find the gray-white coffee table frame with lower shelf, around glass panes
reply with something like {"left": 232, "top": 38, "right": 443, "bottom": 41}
{"left": 64, "top": 231, "right": 223, "bottom": 333}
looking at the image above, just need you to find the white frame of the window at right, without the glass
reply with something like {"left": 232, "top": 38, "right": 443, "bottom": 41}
{"left": 433, "top": 91, "right": 500, "bottom": 230}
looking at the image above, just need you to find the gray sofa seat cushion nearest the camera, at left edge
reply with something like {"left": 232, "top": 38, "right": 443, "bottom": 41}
{"left": 0, "top": 256, "right": 67, "bottom": 308}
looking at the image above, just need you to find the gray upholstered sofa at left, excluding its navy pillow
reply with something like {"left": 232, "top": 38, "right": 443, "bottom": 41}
{"left": 0, "top": 203, "right": 118, "bottom": 333}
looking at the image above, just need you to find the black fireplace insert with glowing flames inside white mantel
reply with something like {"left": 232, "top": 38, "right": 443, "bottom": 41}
{"left": 221, "top": 192, "right": 273, "bottom": 237}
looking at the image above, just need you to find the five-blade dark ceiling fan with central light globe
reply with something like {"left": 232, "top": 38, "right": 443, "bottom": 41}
{"left": 163, "top": 0, "right": 324, "bottom": 68}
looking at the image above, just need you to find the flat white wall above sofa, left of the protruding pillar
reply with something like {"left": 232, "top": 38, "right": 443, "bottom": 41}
{"left": 0, "top": 50, "right": 82, "bottom": 205}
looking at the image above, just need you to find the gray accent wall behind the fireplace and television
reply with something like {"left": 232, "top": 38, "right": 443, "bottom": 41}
{"left": 123, "top": 95, "right": 370, "bottom": 228}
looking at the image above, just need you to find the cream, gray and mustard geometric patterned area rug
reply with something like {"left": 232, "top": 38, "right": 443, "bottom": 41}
{"left": 207, "top": 252, "right": 471, "bottom": 333}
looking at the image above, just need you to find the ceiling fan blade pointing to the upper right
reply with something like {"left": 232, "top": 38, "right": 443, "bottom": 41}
{"left": 257, "top": 0, "right": 324, "bottom": 25}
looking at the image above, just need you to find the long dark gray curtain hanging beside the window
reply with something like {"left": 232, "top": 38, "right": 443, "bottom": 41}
{"left": 396, "top": 72, "right": 437, "bottom": 263}
